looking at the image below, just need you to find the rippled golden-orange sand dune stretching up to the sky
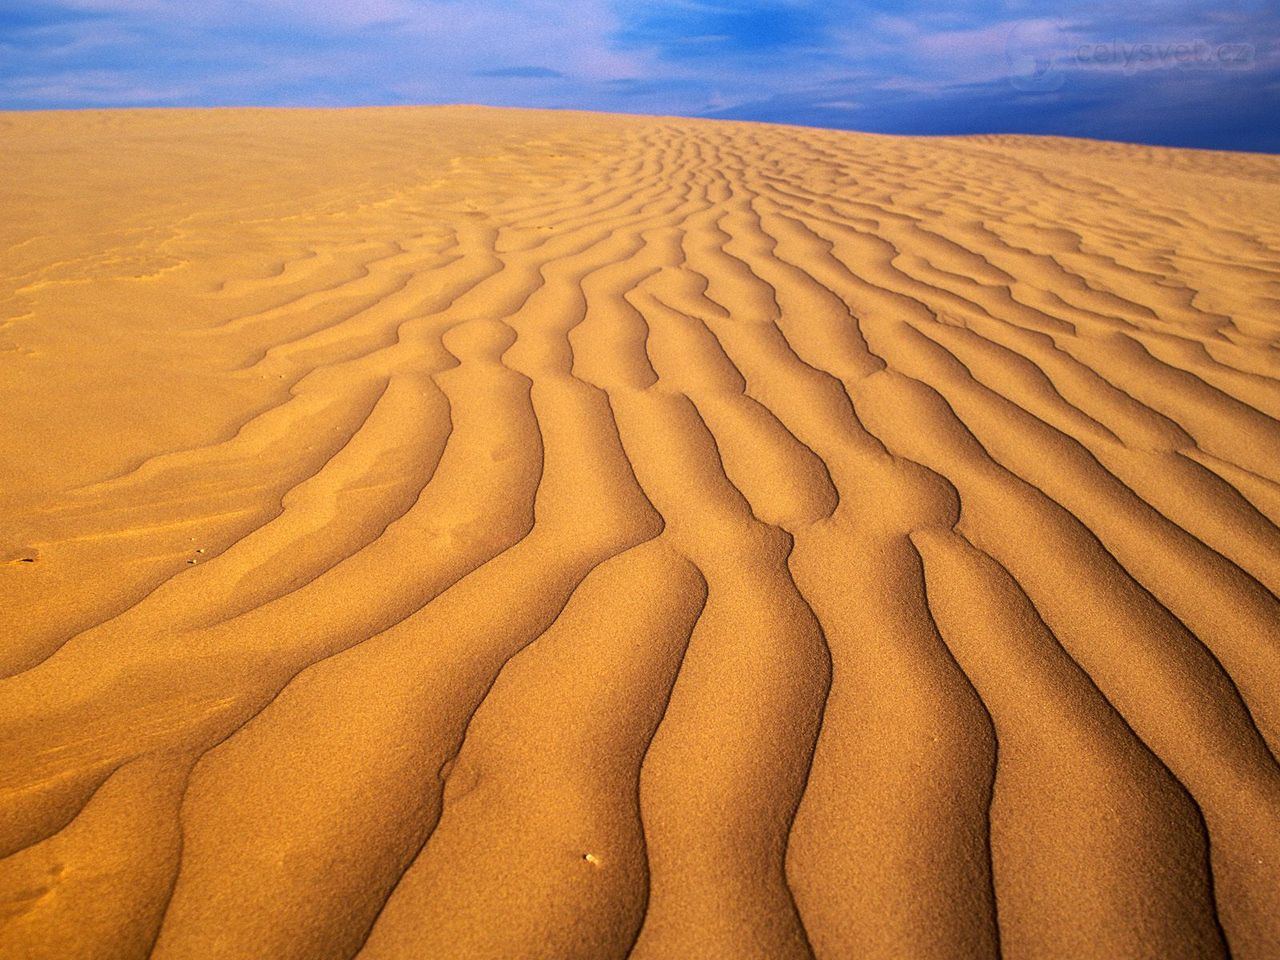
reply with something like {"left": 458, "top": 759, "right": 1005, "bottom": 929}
{"left": 0, "top": 108, "right": 1280, "bottom": 960}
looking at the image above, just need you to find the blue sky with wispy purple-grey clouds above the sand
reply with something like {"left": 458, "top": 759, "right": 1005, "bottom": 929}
{"left": 0, "top": 0, "right": 1280, "bottom": 152}
